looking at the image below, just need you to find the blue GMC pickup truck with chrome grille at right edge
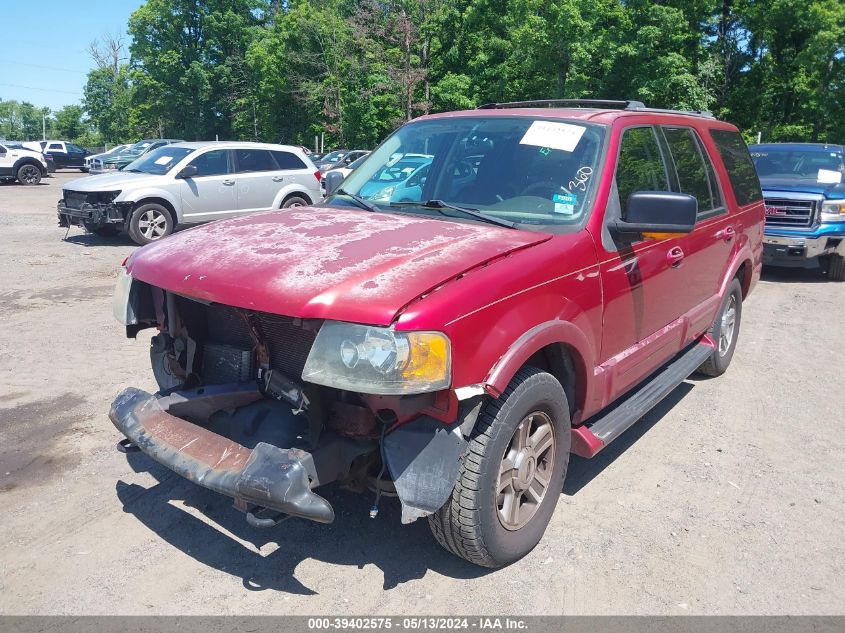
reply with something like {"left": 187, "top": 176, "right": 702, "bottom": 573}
{"left": 749, "top": 143, "right": 845, "bottom": 281}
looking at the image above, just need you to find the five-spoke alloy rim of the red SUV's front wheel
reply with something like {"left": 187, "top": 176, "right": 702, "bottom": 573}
{"left": 496, "top": 411, "right": 555, "bottom": 530}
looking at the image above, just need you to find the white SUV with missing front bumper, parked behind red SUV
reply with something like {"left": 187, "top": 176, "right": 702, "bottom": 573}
{"left": 58, "top": 142, "right": 320, "bottom": 244}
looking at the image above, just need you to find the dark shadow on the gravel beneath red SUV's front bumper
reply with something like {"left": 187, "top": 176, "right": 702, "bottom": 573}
{"left": 116, "top": 453, "right": 492, "bottom": 597}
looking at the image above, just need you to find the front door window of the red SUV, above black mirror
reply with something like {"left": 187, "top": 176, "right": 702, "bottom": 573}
{"left": 616, "top": 127, "right": 670, "bottom": 218}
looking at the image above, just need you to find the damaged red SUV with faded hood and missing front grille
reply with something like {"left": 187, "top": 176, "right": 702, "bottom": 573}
{"left": 110, "top": 100, "right": 764, "bottom": 567}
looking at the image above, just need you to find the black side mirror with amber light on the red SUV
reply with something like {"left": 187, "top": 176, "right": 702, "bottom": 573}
{"left": 610, "top": 191, "right": 698, "bottom": 240}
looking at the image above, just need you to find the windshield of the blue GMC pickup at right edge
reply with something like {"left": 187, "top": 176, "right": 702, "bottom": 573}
{"left": 751, "top": 147, "right": 845, "bottom": 183}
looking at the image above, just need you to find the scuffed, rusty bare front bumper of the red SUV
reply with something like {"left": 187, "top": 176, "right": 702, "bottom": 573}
{"left": 109, "top": 388, "right": 334, "bottom": 523}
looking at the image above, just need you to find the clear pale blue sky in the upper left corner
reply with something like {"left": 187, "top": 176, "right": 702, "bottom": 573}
{"left": 0, "top": 0, "right": 144, "bottom": 111}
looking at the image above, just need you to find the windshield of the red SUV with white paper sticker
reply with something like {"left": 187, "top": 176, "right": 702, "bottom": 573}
{"left": 329, "top": 116, "right": 604, "bottom": 225}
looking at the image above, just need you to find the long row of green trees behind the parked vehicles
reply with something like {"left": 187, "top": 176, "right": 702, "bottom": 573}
{"left": 6, "top": 0, "right": 845, "bottom": 147}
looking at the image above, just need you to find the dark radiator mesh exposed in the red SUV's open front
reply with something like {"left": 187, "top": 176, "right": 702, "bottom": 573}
{"left": 201, "top": 304, "right": 317, "bottom": 380}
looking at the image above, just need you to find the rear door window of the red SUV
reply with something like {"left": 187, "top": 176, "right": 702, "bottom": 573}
{"left": 662, "top": 127, "right": 722, "bottom": 214}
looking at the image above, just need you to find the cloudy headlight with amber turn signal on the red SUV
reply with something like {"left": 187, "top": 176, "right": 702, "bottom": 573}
{"left": 302, "top": 321, "right": 452, "bottom": 395}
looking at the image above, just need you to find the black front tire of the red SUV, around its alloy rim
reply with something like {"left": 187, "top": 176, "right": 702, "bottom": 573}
{"left": 428, "top": 367, "right": 571, "bottom": 567}
